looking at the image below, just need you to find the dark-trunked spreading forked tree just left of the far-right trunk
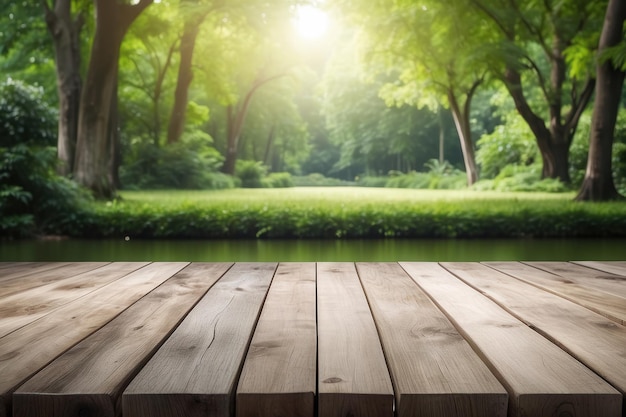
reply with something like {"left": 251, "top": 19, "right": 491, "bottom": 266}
{"left": 470, "top": 0, "right": 603, "bottom": 183}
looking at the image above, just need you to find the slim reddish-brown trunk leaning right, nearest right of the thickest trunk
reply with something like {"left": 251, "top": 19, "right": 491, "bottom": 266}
{"left": 167, "top": 0, "right": 206, "bottom": 143}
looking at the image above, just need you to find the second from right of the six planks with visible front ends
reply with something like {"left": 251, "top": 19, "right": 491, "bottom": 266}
{"left": 357, "top": 263, "right": 508, "bottom": 417}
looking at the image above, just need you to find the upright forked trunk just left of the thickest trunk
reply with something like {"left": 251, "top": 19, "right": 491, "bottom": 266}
{"left": 42, "top": 0, "right": 84, "bottom": 175}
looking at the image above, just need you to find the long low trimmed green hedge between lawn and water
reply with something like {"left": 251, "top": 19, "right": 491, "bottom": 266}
{"left": 60, "top": 201, "right": 626, "bottom": 238}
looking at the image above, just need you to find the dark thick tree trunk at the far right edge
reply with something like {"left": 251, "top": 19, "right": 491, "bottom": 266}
{"left": 576, "top": 0, "right": 626, "bottom": 201}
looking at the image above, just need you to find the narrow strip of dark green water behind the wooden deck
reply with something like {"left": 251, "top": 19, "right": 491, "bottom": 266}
{"left": 0, "top": 239, "right": 626, "bottom": 262}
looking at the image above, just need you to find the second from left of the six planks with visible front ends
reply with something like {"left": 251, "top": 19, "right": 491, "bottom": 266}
{"left": 122, "top": 263, "right": 276, "bottom": 417}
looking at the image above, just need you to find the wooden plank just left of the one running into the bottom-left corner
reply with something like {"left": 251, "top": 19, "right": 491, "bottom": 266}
{"left": 0, "top": 262, "right": 141, "bottom": 338}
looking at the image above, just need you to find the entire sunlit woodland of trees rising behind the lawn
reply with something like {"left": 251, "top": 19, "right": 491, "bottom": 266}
{"left": 0, "top": 0, "right": 626, "bottom": 199}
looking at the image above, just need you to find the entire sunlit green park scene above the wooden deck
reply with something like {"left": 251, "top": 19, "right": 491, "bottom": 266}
{"left": 0, "top": 0, "right": 626, "bottom": 260}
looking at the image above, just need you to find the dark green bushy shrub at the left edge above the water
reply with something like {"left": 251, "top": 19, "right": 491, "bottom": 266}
{"left": 0, "top": 79, "right": 87, "bottom": 237}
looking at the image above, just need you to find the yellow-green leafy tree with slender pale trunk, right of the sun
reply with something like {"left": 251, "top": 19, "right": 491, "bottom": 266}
{"left": 332, "top": 0, "right": 487, "bottom": 185}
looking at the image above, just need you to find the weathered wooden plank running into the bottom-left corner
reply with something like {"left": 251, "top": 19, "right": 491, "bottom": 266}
{"left": 0, "top": 262, "right": 187, "bottom": 417}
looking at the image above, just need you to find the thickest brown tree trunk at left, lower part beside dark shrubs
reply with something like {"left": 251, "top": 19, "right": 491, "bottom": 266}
{"left": 74, "top": 0, "right": 153, "bottom": 198}
